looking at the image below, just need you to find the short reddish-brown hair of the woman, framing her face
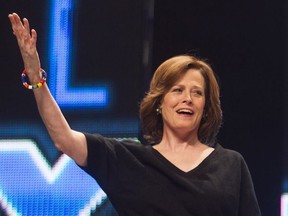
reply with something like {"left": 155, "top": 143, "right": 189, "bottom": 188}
{"left": 140, "top": 55, "right": 222, "bottom": 145}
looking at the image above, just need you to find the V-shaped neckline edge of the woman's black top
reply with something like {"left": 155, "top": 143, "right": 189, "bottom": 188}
{"left": 150, "top": 144, "right": 218, "bottom": 175}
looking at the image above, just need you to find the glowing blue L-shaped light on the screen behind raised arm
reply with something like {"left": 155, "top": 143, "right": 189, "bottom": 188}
{"left": 49, "top": 0, "right": 109, "bottom": 108}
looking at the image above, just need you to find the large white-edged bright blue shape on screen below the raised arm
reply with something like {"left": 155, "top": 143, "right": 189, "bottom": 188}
{"left": 0, "top": 139, "right": 106, "bottom": 216}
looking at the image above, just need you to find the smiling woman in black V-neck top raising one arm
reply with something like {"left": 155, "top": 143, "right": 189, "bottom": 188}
{"left": 9, "top": 13, "right": 261, "bottom": 216}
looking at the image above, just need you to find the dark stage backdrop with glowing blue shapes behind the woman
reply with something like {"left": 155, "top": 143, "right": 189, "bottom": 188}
{"left": 0, "top": 0, "right": 288, "bottom": 216}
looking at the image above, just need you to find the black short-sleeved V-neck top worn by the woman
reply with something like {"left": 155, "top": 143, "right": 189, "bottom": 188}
{"left": 82, "top": 134, "right": 261, "bottom": 216}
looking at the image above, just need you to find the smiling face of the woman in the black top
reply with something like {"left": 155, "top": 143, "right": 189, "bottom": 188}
{"left": 160, "top": 69, "right": 205, "bottom": 137}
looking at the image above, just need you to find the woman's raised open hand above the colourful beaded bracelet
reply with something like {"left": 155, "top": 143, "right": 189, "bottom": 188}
{"left": 8, "top": 13, "right": 41, "bottom": 84}
